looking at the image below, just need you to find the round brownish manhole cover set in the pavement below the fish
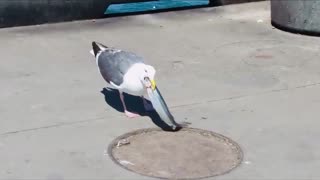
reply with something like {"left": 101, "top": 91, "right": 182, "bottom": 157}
{"left": 108, "top": 128, "right": 243, "bottom": 179}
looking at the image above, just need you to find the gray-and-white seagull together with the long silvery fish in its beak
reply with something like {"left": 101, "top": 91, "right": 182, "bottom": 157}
{"left": 90, "top": 42, "right": 185, "bottom": 130}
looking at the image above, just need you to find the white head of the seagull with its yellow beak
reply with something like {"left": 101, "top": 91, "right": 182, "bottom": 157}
{"left": 141, "top": 65, "right": 156, "bottom": 90}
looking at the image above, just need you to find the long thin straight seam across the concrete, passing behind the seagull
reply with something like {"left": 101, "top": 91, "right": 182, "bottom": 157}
{"left": 0, "top": 82, "right": 320, "bottom": 136}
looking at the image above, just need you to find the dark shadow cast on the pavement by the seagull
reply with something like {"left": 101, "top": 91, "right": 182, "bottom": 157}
{"left": 101, "top": 88, "right": 181, "bottom": 131}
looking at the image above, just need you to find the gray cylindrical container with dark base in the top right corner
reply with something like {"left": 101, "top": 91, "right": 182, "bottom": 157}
{"left": 271, "top": 0, "right": 320, "bottom": 36}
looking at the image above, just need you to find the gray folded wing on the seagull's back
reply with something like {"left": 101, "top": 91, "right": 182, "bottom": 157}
{"left": 98, "top": 48, "right": 143, "bottom": 86}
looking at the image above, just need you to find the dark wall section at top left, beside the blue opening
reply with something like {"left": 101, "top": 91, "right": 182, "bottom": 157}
{"left": 0, "top": 0, "right": 107, "bottom": 27}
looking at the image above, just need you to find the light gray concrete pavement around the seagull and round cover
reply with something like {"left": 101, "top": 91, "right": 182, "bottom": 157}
{"left": 0, "top": 2, "right": 320, "bottom": 180}
